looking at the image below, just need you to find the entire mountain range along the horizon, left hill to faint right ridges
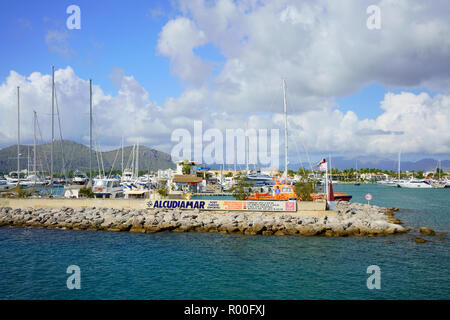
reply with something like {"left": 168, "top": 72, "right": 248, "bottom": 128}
{"left": 0, "top": 140, "right": 450, "bottom": 173}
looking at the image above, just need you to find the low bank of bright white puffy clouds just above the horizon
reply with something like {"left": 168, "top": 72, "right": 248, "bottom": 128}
{"left": 0, "top": 67, "right": 450, "bottom": 164}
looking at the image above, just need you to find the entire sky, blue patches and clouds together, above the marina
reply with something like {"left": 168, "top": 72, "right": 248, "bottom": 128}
{"left": 0, "top": 0, "right": 450, "bottom": 169}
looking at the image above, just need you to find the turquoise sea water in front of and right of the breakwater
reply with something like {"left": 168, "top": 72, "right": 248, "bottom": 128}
{"left": 0, "top": 185, "right": 450, "bottom": 300}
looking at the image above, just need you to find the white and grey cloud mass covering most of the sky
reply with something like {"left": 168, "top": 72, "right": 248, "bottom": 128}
{"left": 0, "top": 0, "right": 450, "bottom": 165}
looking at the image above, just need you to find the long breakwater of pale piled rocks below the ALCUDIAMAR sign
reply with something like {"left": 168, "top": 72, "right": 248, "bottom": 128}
{"left": 0, "top": 202, "right": 409, "bottom": 236}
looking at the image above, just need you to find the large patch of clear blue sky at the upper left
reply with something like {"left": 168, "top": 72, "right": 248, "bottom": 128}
{"left": 0, "top": 0, "right": 183, "bottom": 103}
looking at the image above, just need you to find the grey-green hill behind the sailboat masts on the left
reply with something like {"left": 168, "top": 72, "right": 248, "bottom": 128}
{"left": 0, "top": 140, "right": 175, "bottom": 173}
